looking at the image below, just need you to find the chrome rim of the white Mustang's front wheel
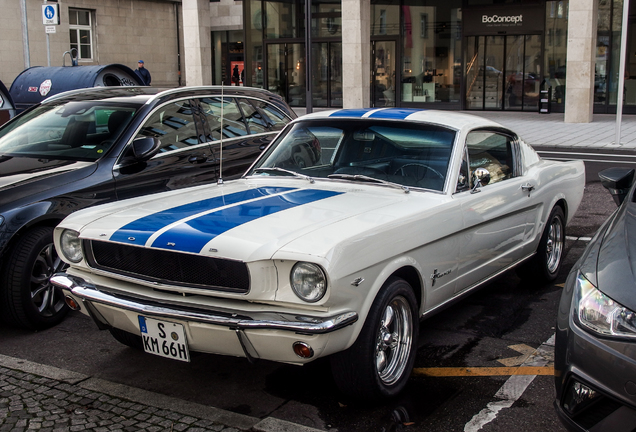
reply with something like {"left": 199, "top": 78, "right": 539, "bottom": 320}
{"left": 375, "top": 296, "right": 413, "bottom": 385}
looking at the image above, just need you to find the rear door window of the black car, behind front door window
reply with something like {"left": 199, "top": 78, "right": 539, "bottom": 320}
{"left": 199, "top": 97, "right": 247, "bottom": 141}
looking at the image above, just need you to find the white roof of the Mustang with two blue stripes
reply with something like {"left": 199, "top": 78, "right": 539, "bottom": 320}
{"left": 295, "top": 108, "right": 508, "bottom": 130}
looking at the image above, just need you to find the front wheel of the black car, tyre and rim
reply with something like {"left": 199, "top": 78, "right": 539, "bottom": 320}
{"left": 0, "top": 227, "right": 69, "bottom": 329}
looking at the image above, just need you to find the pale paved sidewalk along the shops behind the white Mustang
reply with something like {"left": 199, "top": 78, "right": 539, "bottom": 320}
{"left": 294, "top": 108, "right": 636, "bottom": 151}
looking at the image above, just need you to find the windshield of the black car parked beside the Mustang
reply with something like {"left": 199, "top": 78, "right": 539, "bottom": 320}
{"left": 0, "top": 101, "right": 137, "bottom": 161}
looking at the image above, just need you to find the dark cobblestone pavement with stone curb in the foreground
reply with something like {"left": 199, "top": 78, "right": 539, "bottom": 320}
{"left": 0, "top": 355, "right": 318, "bottom": 432}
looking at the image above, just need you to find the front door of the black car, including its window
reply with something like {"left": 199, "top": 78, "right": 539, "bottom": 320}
{"left": 113, "top": 99, "right": 218, "bottom": 199}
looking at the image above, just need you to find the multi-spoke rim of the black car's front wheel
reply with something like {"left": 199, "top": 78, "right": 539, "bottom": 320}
{"left": 30, "top": 243, "right": 66, "bottom": 317}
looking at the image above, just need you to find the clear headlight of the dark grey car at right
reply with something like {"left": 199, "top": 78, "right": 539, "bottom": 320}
{"left": 575, "top": 273, "right": 636, "bottom": 338}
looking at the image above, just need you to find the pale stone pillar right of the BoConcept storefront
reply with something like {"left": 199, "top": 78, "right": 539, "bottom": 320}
{"left": 565, "top": 0, "right": 598, "bottom": 123}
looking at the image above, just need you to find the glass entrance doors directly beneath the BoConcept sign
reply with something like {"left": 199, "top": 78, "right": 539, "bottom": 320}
{"left": 464, "top": 35, "right": 543, "bottom": 111}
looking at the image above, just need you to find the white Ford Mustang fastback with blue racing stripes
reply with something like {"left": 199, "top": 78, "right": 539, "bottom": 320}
{"left": 52, "top": 108, "right": 584, "bottom": 399}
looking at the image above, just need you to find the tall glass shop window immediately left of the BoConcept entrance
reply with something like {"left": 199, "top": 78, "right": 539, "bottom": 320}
{"left": 400, "top": 0, "right": 462, "bottom": 103}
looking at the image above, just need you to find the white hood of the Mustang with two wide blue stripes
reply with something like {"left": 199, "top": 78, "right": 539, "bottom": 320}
{"left": 66, "top": 179, "right": 454, "bottom": 262}
